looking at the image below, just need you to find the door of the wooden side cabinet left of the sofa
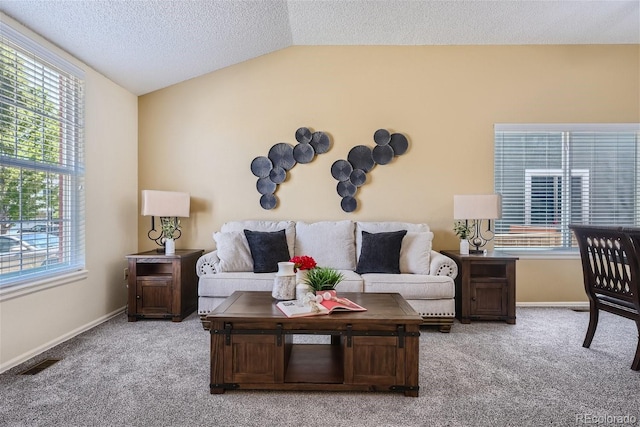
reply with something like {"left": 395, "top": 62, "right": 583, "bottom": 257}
{"left": 136, "top": 276, "right": 173, "bottom": 315}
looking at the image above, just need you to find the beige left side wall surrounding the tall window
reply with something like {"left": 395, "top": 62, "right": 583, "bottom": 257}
{"left": 0, "top": 15, "right": 138, "bottom": 372}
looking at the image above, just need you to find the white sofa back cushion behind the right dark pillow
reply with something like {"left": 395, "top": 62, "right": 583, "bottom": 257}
{"left": 356, "top": 221, "right": 433, "bottom": 274}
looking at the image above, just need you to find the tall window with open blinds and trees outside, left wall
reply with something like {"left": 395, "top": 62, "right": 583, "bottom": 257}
{"left": 0, "top": 24, "right": 84, "bottom": 289}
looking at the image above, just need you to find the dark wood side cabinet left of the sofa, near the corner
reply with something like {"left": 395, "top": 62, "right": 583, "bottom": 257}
{"left": 127, "top": 249, "right": 204, "bottom": 322}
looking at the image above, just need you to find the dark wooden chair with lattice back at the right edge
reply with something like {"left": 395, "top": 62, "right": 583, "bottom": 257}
{"left": 569, "top": 225, "right": 640, "bottom": 371}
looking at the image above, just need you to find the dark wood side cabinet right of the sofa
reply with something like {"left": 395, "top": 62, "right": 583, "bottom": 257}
{"left": 441, "top": 251, "right": 518, "bottom": 325}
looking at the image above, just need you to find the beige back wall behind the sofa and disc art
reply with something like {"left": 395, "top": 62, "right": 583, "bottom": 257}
{"left": 138, "top": 45, "right": 640, "bottom": 302}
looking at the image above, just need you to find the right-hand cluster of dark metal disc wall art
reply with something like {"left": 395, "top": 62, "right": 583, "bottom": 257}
{"left": 331, "top": 129, "right": 409, "bottom": 212}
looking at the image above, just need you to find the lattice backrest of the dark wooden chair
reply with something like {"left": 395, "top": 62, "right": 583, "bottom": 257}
{"left": 569, "top": 225, "right": 640, "bottom": 312}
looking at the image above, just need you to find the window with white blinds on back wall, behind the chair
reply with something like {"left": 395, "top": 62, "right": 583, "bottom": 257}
{"left": 494, "top": 124, "right": 640, "bottom": 251}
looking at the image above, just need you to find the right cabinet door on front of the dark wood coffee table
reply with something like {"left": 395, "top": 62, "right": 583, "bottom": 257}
{"left": 343, "top": 336, "right": 405, "bottom": 386}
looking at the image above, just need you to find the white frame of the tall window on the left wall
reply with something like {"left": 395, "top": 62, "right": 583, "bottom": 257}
{"left": 0, "top": 22, "right": 87, "bottom": 294}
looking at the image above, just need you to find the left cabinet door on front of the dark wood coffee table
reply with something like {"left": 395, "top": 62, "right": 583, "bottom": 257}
{"left": 224, "top": 334, "right": 284, "bottom": 384}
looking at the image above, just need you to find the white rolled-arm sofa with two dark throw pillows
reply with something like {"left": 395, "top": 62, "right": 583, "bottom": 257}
{"left": 196, "top": 220, "right": 458, "bottom": 332}
